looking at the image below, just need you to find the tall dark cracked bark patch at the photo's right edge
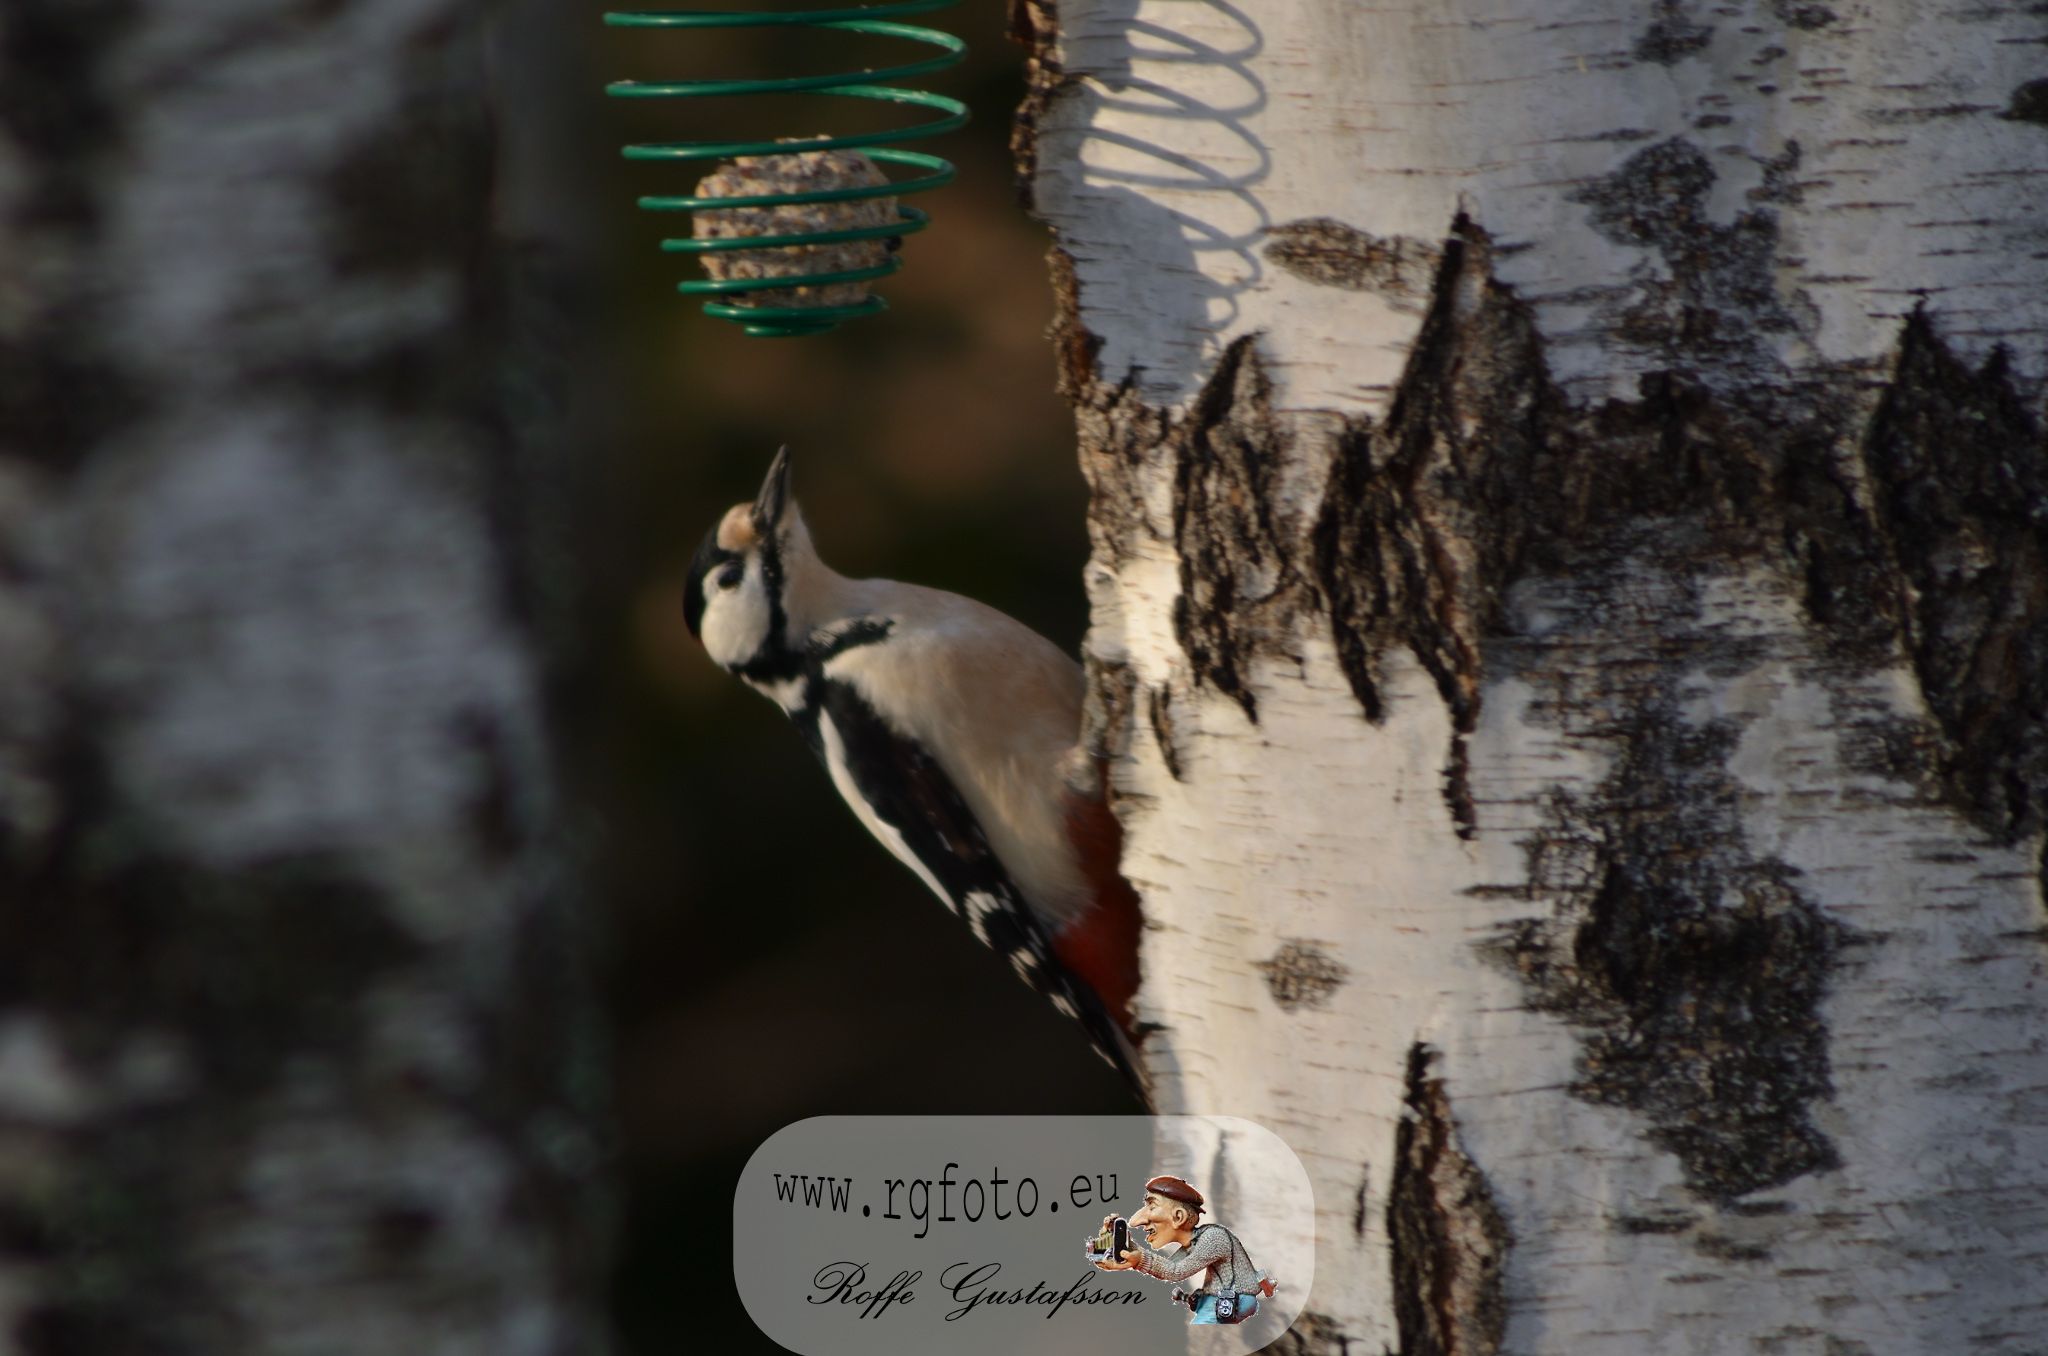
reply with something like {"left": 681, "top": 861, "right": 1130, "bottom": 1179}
{"left": 1862, "top": 311, "right": 2048, "bottom": 842}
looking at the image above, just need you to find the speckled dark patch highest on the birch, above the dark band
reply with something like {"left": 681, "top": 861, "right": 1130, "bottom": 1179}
{"left": 1569, "top": 137, "right": 1798, "bottom": 379}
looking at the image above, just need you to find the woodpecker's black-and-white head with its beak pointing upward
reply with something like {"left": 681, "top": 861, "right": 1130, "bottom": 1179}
{"left": 682, "top": 447, "right": 811, "bottom": 676}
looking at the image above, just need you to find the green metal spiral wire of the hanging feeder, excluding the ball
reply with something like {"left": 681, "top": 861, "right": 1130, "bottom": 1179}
{"left": 604, "top": 0, "right": 967, "bottom": 338}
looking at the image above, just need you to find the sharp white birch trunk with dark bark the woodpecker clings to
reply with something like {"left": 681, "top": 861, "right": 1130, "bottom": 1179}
{"left": 1014, "top": 0, "right": 2048, "bottom": 1356}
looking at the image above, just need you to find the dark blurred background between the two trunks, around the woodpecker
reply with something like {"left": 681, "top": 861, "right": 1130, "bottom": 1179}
{"left": 498, "top": 0, "right": 1137, "bottom": 1356}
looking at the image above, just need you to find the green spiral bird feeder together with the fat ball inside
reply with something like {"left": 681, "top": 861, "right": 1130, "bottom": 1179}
{"left": 604, "top": 0, "right": 967, "bottom": 338}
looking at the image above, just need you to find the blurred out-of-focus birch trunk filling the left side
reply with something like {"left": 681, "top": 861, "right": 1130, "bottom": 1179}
{"left": 0, "top": 0, "right": 604, "bottom": 1356}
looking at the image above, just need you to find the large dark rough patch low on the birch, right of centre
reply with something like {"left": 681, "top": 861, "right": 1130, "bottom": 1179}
{"left": 1499, "top": 670, "right": 1847, "bottom": 1202}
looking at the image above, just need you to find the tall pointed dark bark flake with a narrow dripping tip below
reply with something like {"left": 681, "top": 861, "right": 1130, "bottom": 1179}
{"left": 1315, "top": 217, "right": 1561, "bottom": 834}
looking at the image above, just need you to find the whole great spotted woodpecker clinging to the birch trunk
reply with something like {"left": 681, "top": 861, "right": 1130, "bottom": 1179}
{"left": 682, "top": 449, "right": 1145, "bottom": 1094}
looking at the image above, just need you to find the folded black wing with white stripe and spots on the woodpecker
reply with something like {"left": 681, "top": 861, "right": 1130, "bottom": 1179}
{"left": 805, "top": 675, "right": 1145, "bottom": 1096}
